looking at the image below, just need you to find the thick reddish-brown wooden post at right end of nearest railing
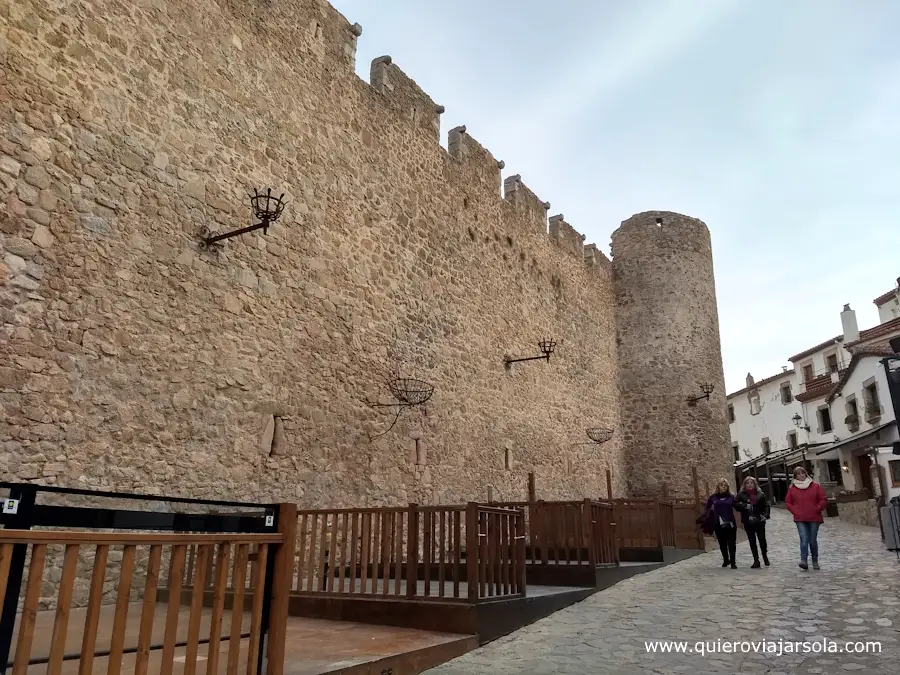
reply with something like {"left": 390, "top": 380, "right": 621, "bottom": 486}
{"left": 264, "top": 504, "right": 297, "bottom": 675}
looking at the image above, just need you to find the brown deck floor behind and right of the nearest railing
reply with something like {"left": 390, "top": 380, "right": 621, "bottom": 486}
{"left": 13, "top": 602, "right": 477, "bottom": 675}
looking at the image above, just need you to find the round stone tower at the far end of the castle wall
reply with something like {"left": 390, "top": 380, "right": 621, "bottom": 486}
{"left": 612, "top": 211, "right": 734, "bottom": 497}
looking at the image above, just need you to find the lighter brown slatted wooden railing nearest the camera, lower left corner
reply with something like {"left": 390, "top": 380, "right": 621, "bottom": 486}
{"left": 0, "top": 532, "right": 293, "bottom": 675}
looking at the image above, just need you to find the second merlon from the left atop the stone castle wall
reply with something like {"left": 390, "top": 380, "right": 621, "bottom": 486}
{"left": 369, "top": 56, "right": 444, "bottom": 141}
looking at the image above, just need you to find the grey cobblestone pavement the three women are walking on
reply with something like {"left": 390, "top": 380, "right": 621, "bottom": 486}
{"left": 427, "top": 510, "right": 900, "bottom": 675}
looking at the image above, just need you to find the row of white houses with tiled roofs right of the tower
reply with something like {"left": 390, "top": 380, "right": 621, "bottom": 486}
{"left": 727, "top": 280, "right": 900, "bottom": 510}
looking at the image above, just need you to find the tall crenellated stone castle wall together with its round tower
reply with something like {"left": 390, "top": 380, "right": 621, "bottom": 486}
{"left": 0, "top": 0, "right": 731, "bottom": 506}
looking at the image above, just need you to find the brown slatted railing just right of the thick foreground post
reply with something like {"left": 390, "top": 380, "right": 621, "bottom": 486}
{"left": 292, "top": 503, "right": 525, "bottom": 602}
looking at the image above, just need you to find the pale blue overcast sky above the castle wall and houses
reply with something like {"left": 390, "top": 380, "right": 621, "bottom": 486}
{"left": 332, "top": 0, "right": 900, "bottom": 391}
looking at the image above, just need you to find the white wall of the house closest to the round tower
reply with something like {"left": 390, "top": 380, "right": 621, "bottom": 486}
{"left": 728, "top": 373, "right": 804, "bottom": 462}
